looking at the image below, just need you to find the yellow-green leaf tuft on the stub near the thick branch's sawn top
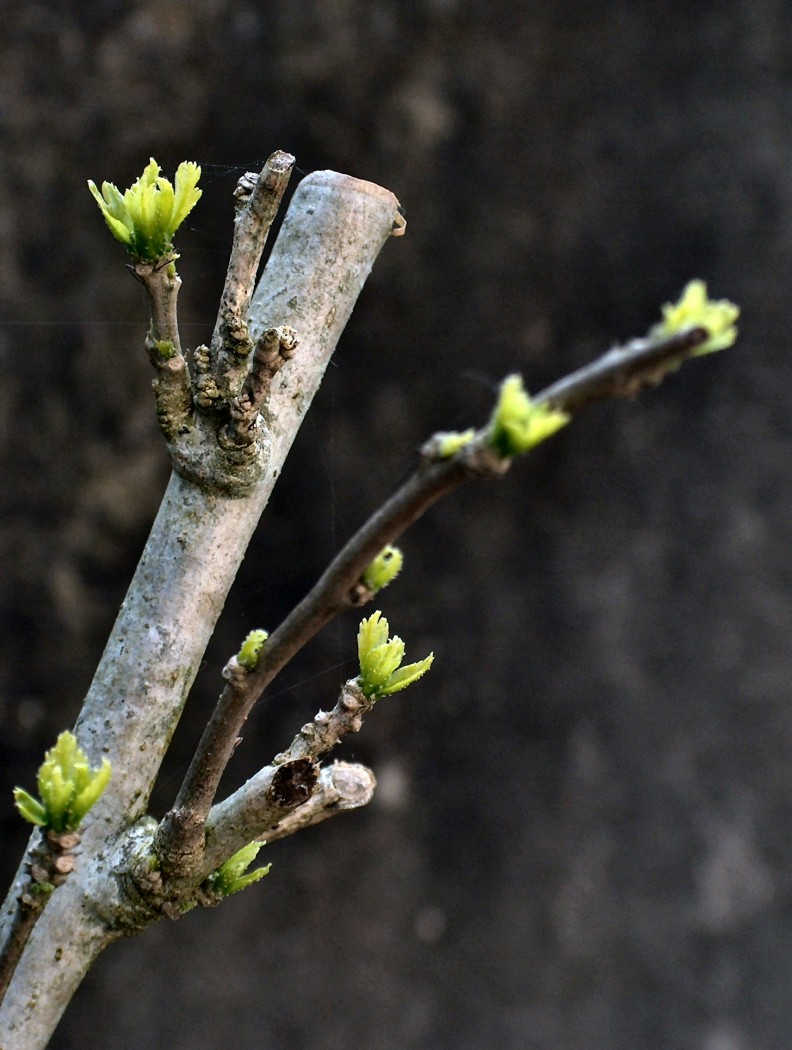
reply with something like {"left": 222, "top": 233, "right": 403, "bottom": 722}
{"left": 88, "top": 158, "right": 202, "bottom": 263}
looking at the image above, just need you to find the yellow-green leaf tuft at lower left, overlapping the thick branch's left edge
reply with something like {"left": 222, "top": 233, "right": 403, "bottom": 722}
{"left": 14, "top": 732, "right": 111, "bottom": 832}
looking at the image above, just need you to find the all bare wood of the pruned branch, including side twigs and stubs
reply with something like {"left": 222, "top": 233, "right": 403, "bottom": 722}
{"left": 0, "top": 145, "right": 733, "bottom": 1048}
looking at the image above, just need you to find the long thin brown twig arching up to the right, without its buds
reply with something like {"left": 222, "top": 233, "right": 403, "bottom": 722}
{"left": 155, "top": 328, "right": 709, "bottom": 875}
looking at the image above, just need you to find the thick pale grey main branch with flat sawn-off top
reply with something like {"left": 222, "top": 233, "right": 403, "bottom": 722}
{"left": 0, "top": 171, "right": 400, "bottom": 1050}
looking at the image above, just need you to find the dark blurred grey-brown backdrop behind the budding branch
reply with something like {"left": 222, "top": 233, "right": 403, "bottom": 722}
{"left": 0, "top": 0, "right": 792, "bottom": 1050}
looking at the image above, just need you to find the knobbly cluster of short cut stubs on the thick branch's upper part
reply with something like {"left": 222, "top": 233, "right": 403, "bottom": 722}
{"left": 131, "top": 150, "right": 297, "bottom": 496}
